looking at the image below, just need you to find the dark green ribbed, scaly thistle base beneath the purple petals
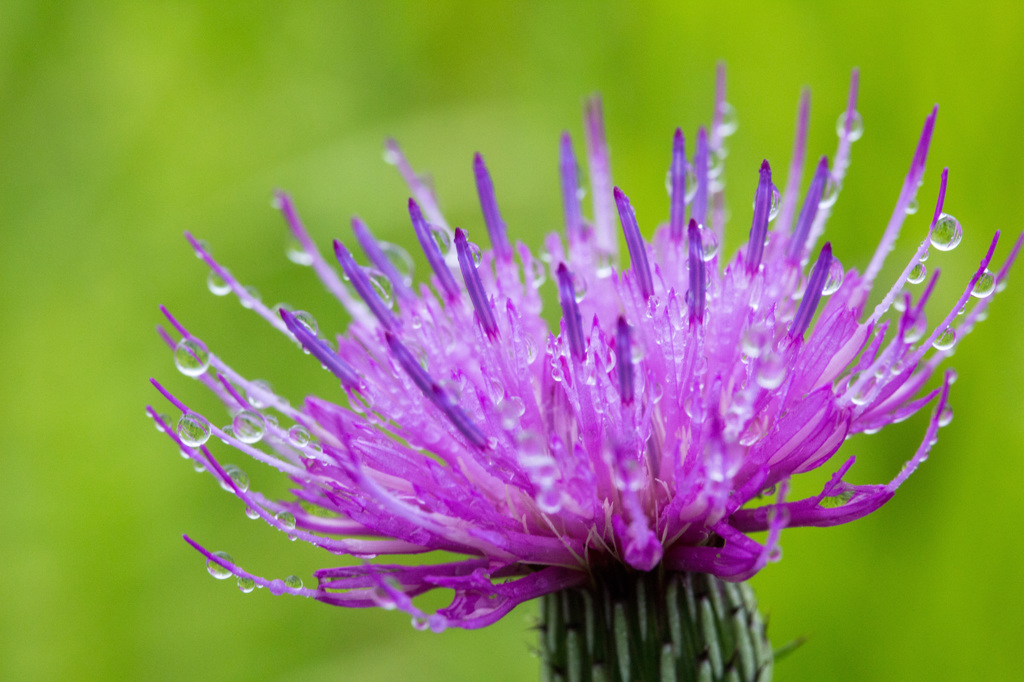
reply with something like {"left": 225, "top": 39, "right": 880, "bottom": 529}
{"left": 540, "top": 569, "right": 773, "bottom": 682}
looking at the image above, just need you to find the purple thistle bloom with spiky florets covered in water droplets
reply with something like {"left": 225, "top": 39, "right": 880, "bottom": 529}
{"left": 147, "top": 72, "right": 1022, "bottom": 630}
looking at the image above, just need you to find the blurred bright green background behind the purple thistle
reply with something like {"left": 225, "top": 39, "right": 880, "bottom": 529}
{"left": 0, "top": 0, "right": 1024, "bottom": 680}
